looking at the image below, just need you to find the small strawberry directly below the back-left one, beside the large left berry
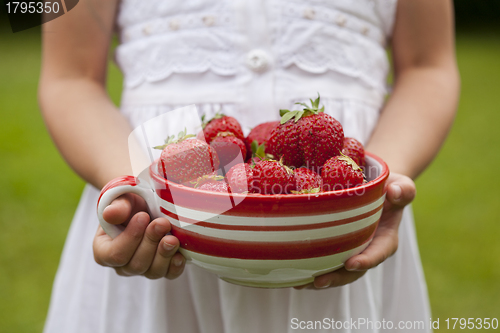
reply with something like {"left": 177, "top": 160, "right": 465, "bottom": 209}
{"left": 210, "top": 132, "right": 247, "bottom": 170}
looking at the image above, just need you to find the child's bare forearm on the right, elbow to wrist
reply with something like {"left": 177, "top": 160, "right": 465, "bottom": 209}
{"left": 367, "top": 64, "right": 459, "bottom": 179}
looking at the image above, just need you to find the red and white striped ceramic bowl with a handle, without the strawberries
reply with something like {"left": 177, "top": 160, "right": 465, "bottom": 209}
{"left": 98, "top": 153, "right": 389, "bottom": 287}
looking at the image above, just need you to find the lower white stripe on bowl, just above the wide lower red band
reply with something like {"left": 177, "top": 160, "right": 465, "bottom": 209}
{"left": 169, "top": 210, "right": 382, "bottom": 242}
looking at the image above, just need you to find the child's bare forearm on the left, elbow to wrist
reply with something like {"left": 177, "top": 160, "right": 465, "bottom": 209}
{"left": 39, "top": 75, "right": 131, "bottom": 188}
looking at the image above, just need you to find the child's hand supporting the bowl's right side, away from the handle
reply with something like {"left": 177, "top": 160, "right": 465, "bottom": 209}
{"left": 295, "top": 173, "right": 416, "bottom": 289}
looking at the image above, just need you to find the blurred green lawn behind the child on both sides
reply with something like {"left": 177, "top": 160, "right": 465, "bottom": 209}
{"left": 0, "top": 29, "right": 500, "bottom": 333}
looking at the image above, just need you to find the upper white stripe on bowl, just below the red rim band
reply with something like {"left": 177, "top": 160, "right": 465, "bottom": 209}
{"left": 158, "top": 194, "right": 385, "bottom": 226}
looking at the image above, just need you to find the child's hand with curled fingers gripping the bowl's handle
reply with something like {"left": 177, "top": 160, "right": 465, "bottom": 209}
{"left": 93, "top": 194, "right": 185, "bottom": 279}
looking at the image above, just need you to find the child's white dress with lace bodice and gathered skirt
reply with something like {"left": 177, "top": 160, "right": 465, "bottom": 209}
{"left": 45, "top": 0, "right": 430, "bottom": 333}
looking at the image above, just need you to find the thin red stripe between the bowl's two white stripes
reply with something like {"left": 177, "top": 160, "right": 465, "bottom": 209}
{"left": 160, "top": 204, "right": 383, "bottom": 231}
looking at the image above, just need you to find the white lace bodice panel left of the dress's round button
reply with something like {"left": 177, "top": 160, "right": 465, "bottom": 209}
{"left": 115, "top": 0, "right": 238, "bottom": 88}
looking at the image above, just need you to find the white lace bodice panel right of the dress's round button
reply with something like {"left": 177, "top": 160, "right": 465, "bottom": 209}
{"left": 274, "top": 3, "right": 389, "bottom": 87}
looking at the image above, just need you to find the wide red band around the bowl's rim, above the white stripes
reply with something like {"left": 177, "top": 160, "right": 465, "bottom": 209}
{"left": 150, "top": 153, "right": 389, "bottom": 217}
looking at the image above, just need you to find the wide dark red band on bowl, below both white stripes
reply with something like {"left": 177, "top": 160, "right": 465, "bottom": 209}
{"left": 172, "top": 221, "right": 378, "bottom": 260}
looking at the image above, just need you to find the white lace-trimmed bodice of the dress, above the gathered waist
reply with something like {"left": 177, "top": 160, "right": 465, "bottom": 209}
{"left": 116, "top": 0, "right": 396, "bottom": 113}
